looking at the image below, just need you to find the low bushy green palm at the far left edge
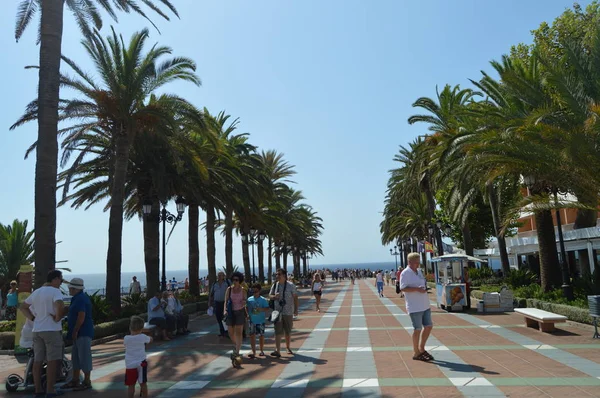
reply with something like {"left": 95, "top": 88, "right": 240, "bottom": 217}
{"left": 0, "top": 220, "right": 35, "bottom": 291}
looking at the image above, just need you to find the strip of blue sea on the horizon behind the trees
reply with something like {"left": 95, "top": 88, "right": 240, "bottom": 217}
{"left": 64, "top": 261, "right": 395, "bottom": 294}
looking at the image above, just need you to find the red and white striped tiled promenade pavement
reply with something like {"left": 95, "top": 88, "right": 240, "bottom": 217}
{"left": 0, "top": 279, "right": 600, "bottom": 398}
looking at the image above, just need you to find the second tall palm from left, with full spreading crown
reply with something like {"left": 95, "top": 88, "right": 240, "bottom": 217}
{"left": 13, "top": 29, "right": 201, "bottom": 311}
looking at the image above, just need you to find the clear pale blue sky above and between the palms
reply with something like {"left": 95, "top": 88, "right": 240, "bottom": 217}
{"left": 0, "top": 0, "right": 588, "bottom": 273}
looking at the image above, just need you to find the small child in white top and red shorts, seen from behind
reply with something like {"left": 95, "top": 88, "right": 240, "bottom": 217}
{"left": 123, "top": 316, "right": 152, "bottom": 398}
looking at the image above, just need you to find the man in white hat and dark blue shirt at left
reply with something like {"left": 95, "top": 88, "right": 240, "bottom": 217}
{"left": 63, "top": 278, "right": 94, "bottom": 391}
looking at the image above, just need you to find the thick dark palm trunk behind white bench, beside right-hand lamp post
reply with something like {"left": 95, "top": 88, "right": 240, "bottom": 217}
{"left": 534, "top": 210, "right": 561, "bottom": 292}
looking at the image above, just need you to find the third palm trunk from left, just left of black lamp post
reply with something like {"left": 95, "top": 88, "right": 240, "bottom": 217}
{"left": 144, "top": 198, "right": 160, "bottom": 297}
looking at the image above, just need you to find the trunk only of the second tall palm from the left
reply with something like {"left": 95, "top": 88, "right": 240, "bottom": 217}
{"left": 106, "top": 131, "right": 132, "bottom": 314}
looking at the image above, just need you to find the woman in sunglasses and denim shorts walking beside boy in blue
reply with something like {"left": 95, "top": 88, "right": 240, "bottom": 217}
{"left": 223, "top": 272, "right": 247, "bottom": 361}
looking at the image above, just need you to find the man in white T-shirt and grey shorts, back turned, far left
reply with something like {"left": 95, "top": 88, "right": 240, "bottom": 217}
{"left": 21, "top": 270, "right": 65, "bottom": 397}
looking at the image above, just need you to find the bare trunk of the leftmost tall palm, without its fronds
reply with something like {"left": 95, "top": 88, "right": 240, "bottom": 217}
{"left": 34, "top": 1, "right": 64, "bottom": 288}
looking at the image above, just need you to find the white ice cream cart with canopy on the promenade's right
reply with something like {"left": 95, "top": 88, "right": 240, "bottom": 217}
{"left": 431, "top": 254, "right": 486, "bottom": 311}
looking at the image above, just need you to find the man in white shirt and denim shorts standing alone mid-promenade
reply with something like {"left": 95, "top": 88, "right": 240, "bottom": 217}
{"left": 400, "top": 253, "right": 434, "bottom": 361}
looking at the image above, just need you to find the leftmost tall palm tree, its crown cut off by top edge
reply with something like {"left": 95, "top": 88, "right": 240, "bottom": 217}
{"left": 15, "top": 0, "right": 177, "bottom": 286}
